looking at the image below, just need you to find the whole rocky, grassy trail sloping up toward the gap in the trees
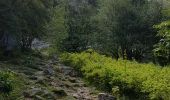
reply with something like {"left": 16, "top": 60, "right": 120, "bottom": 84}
{"left": 0, "top": 39, "right": 115, "bottom": 100}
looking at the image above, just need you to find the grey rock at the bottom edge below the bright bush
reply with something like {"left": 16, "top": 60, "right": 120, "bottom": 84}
{"left": 98, "top": 93, "right": 117, "bottom": 100}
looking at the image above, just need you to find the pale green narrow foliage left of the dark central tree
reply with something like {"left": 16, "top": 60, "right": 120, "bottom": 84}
{"left": 44, "top": 0, "right": 68, "bottom": 53}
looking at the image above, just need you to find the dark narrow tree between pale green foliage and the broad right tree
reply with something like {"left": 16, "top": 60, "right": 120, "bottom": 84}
{"left": 63, "top": 0, "right": 93, "bottom": 52}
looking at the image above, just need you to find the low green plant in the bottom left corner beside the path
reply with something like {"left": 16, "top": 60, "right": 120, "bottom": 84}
{"left": 0, "top": 71, "right": 24, "bottom": 100}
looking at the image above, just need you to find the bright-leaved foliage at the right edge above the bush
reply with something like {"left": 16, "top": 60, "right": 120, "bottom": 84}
{"left": 154, "top": 21, "right": 170, "bottom": 66}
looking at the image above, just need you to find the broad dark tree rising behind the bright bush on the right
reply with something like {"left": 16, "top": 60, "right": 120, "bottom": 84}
{"left": 96, "top": 0, "right": 161, "bottom": 61}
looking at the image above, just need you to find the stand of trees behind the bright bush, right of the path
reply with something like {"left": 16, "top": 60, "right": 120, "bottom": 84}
{"left": 50, "top": 0, "right": 169, "bottom": 66}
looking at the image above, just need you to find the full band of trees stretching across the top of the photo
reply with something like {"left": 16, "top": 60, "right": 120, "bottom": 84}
{"left": 0, "top": 0, "right": 169, "bottom": 66}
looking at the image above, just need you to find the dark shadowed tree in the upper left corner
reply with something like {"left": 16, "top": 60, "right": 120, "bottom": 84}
{"left": 0, "top": 0, "right": 52, "bottom": 50}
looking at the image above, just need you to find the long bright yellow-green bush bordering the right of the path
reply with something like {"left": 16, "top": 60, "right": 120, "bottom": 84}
{"left": 61, "top": 50, "right": 170, "bottom": 100}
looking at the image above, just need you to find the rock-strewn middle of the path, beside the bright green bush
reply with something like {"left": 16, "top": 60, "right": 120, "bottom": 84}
{"left": 22, "top": 60, "right": 99, "bottom": 100}
